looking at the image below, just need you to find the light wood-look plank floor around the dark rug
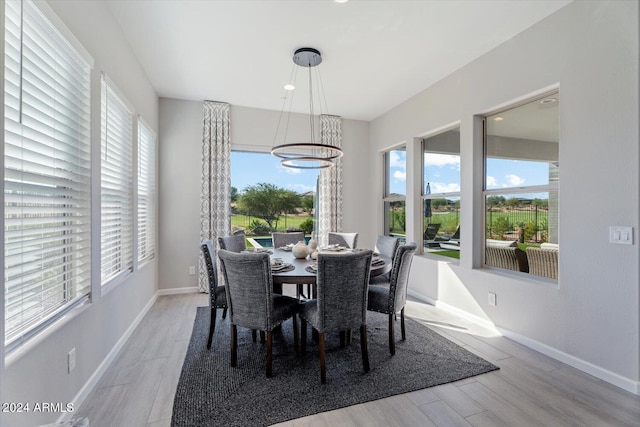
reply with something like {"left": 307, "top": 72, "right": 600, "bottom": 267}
{"left": 74, "top": 294, "right": 640, "bottom": 427}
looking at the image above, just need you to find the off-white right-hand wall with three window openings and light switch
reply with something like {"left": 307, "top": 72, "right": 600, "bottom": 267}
{"left": 370, "top": 1, "right": 640, "bottom": 393}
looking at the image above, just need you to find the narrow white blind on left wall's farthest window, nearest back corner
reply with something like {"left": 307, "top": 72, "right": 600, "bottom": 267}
{"left": 138, "top": 121, "right": 156, "bottom": 262}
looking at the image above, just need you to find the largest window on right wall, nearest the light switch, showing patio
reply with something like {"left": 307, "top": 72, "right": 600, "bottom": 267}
{"left": 484, "top": 92, "right": 560, "bottom": 278}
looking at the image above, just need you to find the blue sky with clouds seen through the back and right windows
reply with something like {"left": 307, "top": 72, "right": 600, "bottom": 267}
{"left": 231, "top": 150, "right": 549, "bottom": 198}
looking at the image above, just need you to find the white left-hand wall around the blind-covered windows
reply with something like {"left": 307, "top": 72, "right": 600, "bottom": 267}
{"left": 0, "top": 0, "right": 158, "bottom": 427}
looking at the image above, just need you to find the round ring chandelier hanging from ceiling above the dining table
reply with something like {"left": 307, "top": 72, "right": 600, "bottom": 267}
{"left": 271, "top": 47, "right": 342, "bottom": 169}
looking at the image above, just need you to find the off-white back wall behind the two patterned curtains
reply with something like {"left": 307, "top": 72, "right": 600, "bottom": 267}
{"left": 159, "top": 98, "right": 375, "bottom": 292}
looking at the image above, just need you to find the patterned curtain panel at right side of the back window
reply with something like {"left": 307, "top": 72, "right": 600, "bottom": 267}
{"left": 316, "top": 114, "right": 342, "bottom": 246}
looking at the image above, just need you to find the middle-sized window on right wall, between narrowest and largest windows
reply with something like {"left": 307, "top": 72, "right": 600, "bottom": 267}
{"left": 422, "top": 128, "right": 460, "bottom": 258}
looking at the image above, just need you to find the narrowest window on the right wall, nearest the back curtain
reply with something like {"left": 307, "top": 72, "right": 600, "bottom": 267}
{"left": 383, "top": 147, "right": 407, "bottom": 239}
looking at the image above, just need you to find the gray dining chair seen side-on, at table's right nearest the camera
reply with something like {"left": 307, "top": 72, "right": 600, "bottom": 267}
{"left": 367, "top": 242, "right": 418, "bottom": 355}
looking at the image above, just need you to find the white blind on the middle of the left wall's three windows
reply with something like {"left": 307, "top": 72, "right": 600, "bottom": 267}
{"left": 100, "top": 76, "right": 133, "bottom": 285}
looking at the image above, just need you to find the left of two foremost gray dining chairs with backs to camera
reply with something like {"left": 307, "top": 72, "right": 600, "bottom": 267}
{"left": 218, "top": 249, "right": 300, "bottom": 377}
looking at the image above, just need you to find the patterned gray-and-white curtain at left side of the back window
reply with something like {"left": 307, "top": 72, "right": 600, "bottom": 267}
{"left": 198, "top": 101, "right": 231, "bottom": 292}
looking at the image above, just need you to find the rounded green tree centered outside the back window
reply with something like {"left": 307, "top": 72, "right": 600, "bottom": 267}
{"left": 237, "top": 182, "right": 300, "bottom": 230}
